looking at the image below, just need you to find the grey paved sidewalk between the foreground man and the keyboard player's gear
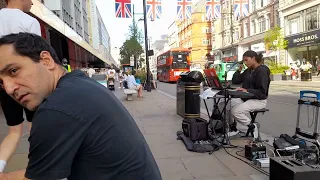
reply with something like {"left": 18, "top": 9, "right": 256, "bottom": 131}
{"left": 115, "top": 89, "right": 269, "bottom": 180}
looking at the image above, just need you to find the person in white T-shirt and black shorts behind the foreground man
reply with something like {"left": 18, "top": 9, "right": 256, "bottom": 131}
{"left": 0, "top": 0, "right": 41, "bottom": 173}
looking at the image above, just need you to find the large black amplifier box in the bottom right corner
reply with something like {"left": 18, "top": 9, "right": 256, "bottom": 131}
{"left": 270, "top": 156, "right": 320, "bottom": 180}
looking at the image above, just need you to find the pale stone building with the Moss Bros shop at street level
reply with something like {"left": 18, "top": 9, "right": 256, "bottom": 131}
{"left": 279, "top": 0, "right": 320, "bottom": 66}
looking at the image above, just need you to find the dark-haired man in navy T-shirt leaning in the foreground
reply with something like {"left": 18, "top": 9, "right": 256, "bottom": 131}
{"left": 0, "top": 33, "right": 161, "bottom": 180}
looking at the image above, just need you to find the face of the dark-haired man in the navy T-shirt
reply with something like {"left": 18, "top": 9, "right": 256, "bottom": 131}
{"left": 0, "top": 45, "right": 57, "bottom": 110}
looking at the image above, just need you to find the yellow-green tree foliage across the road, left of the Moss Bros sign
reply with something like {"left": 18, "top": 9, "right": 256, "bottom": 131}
{"left": 264, "top": 26, "right": 288, "bottom": 51}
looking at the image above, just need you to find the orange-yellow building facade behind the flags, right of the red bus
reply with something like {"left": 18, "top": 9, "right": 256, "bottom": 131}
{"left": 177, "top": 0, "right": 212, "bottom": 68}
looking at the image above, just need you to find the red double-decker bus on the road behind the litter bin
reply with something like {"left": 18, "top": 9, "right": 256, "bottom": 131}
{"left": 157, "top": 48, "right": 190, "bottom": 82}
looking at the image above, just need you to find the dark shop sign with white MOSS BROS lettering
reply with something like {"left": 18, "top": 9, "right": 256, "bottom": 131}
{"left": 285, "top": 30, "right": 320, "bottom": 48}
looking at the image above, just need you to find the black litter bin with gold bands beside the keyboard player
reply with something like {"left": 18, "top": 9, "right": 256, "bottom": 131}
{"left": 177, "top": 71, "right": 203, "bottom": 118}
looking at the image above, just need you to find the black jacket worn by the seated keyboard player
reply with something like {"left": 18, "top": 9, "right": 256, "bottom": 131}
{"left": 232, "top": 65, "right": 270, "bottom": 100}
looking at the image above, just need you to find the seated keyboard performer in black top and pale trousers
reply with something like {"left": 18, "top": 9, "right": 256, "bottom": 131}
{"left": 219, "top": 50, "right": 270, "bottom": 136}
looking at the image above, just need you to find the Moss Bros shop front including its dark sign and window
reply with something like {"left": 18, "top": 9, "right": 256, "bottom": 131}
{"left": 286, "top": 29, "right": 320, "bottom": 67}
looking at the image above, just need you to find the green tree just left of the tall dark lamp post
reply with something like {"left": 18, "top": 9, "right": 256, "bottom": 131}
{"left": 120, "top": 21, "right": 143, "bottom": 65}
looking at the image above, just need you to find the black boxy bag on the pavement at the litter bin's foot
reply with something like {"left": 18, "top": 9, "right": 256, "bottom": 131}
{"left": 182, "top": 118, "right": 208, "bottom": 141}
